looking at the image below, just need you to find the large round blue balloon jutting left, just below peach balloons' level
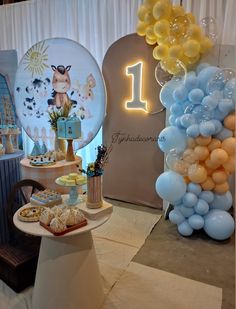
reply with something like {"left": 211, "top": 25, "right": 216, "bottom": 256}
{"left": 155, "top": 171, "right": 187, "bottom": 203}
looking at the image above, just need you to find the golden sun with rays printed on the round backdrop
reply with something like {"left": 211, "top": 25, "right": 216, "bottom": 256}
{"left": 23, "top": 41, "right": 49, "bottom": 77}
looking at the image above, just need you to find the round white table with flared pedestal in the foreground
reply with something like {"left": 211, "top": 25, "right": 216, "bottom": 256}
{"left": 13, "top": 201, "right": 111, "bottom": 309}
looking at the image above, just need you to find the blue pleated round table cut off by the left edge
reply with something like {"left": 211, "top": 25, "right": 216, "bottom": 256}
{"left": 0, "top": 151, "right": 24, "bottom": 244}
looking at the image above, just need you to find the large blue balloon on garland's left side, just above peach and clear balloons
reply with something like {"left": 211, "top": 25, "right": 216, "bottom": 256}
{"left": 158, "top": 126, "right": 187, "bottom": 152}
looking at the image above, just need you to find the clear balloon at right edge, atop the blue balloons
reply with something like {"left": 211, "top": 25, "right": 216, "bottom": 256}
{"left": 206, "top": 69, "right": 236, "bottom": 94}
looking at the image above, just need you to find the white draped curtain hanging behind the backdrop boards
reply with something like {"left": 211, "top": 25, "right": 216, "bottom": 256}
{"left": 0, "top": 0, "right": 236, "bottom": 164}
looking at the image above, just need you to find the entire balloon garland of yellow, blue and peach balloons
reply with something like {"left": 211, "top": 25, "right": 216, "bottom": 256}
{"left": 137, "top": 0, "right": 236, "bottom": 240}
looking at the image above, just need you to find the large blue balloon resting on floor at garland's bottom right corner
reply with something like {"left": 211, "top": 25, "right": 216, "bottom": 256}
{"left": 204, "top": 209, "right": 234, "bottom": 240}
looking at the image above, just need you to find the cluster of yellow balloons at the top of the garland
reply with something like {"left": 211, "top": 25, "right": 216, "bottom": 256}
{"left": 136, "top": 0, "right": 213, "bottom": 74}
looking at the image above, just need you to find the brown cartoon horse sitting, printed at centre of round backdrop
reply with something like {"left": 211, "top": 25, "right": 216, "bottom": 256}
{"left": 48, "top": 65, "right": 77, "bottom": 109}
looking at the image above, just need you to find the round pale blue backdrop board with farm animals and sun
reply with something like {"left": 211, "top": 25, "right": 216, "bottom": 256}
{"left": 14, "top": 38, "right": 106, "bottom": 149}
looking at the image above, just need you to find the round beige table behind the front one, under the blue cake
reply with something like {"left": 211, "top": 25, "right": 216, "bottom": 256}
{"left": 20, "top": 157, "right": 82, "bottom": 194}
